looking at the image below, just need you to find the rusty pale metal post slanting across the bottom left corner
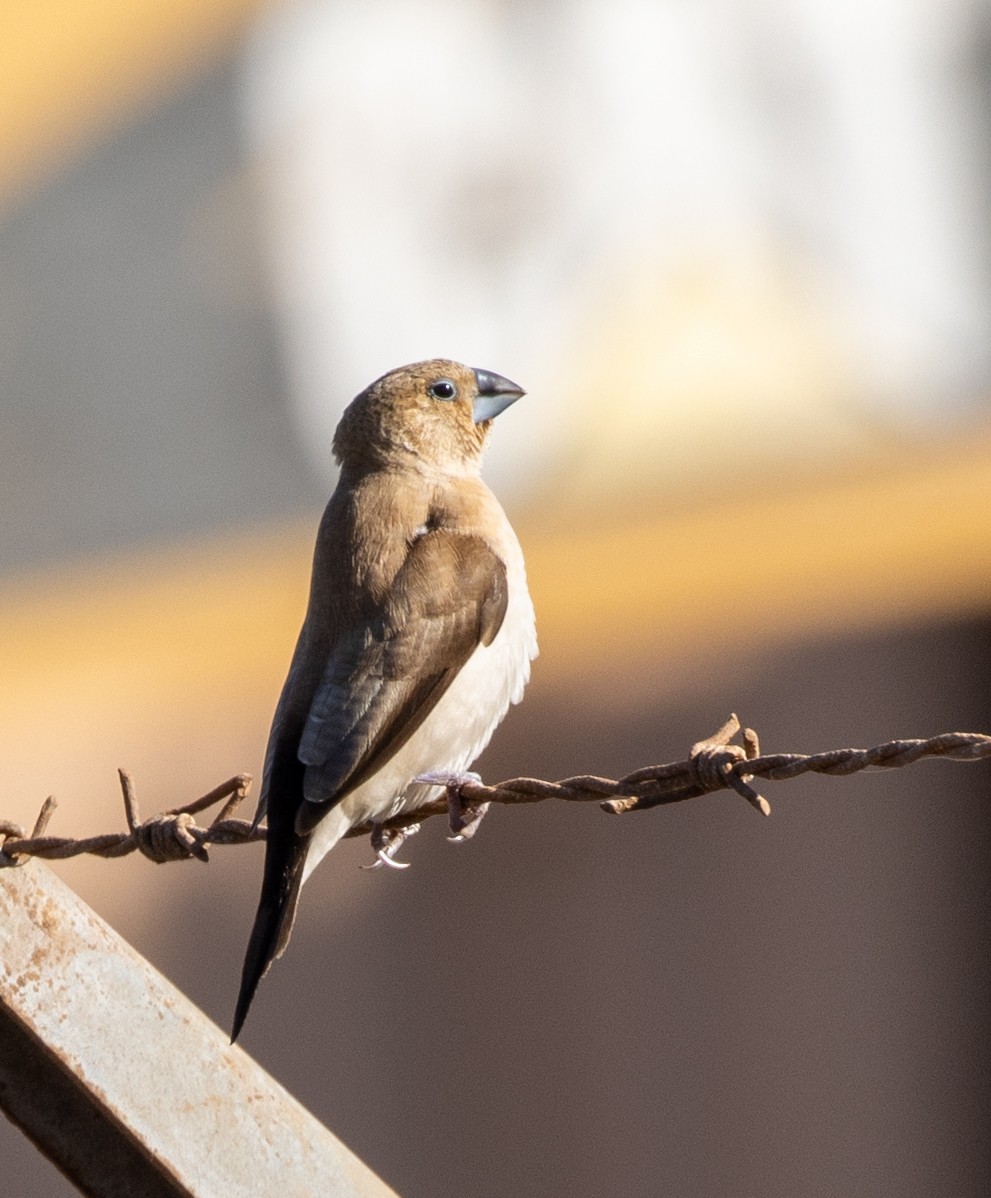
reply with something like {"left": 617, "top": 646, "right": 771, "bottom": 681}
{"left": 0, "top": 861, "right": 395, "bottom": 1198}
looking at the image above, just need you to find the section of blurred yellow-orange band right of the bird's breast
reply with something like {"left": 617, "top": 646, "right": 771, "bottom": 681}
{"left": 526, "top": 430, "right": 991, "bottom": 671}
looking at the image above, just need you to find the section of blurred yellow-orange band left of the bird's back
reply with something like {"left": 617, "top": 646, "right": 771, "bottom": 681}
{"left": 0, "top": 518, "right": 316, "bottom": 703}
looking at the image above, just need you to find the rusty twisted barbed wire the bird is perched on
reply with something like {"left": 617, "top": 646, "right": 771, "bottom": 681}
{"left": 0, "top": 715, "right": 991, "bottom": 867}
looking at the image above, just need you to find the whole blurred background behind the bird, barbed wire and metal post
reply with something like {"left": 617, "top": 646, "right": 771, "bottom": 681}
{"left": 0, "top": 0, "right": 991, "bottom": 1198}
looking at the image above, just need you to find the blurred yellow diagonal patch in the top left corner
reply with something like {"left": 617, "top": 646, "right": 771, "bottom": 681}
{"left": 0, "top": 0, "right": 264, "bottom": 204}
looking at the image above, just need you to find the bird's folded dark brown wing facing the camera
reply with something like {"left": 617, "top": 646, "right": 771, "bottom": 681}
{"left": 296, "top": 530, "right": 508, "bottom": 834}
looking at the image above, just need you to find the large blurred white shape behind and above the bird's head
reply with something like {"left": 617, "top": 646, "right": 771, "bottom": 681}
{"left": 246, "top": 0, "right": 991, "bottom": 495}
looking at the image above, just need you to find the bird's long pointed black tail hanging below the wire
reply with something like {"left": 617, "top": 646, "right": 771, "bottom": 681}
{"left": 230, "top": 828, "right": 309, "bottom": 1043}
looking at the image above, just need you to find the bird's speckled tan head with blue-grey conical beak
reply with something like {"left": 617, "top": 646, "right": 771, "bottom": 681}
{"left": 334, "top": 358, "right": 524, "bottom": 474}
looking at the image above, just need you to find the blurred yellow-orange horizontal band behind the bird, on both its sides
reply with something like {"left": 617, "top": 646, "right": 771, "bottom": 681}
{"left": 0, "top": 434, "right": 991, "bottom": 702}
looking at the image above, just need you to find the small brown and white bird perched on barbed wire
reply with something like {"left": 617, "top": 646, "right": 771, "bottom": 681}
{"left": 231, "top": 358, "right": 537, "bottom": 1043}
